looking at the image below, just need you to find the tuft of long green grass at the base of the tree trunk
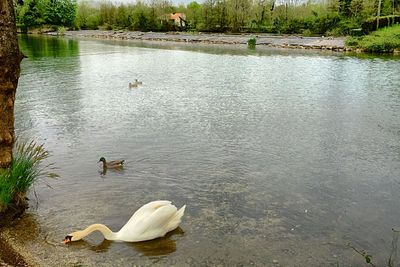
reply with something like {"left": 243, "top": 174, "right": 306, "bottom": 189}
{"left": 0, "top": 141, "right": 56, "bottom": 212}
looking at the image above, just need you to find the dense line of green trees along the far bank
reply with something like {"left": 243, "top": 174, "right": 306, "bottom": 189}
{"left": 17, "top": 0, "right": 400, "bottom": 35}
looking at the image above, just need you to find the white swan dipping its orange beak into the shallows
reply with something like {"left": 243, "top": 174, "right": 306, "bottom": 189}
{"left": 64, "top": 200, "right": 186, "bottom": 244}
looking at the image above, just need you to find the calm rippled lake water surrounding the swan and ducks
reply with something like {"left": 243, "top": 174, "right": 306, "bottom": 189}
{"left": 15, "top": 37, "right": 400, "bottom": 266}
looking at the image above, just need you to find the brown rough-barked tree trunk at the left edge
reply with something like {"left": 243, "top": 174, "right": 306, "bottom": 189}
{"left": 0, "top": 0, "right": 23, "bottom": 168}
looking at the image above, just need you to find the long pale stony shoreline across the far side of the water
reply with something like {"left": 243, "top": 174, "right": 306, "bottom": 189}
{"left": 61, "top": 30, "right": 353, "bottom": 52}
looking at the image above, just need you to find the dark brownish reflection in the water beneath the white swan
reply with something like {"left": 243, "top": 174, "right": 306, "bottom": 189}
{"left": 81, "top": 227, "right": 184, "bottom": 257}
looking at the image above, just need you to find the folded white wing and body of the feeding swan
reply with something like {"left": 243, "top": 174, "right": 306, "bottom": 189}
{"left": 117, "top": 201, "right": 181, "bottom": 241}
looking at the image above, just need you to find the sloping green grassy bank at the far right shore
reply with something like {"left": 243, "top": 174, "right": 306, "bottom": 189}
{"left": 346, "top": 25, "right": 400, "bottom": 53}
